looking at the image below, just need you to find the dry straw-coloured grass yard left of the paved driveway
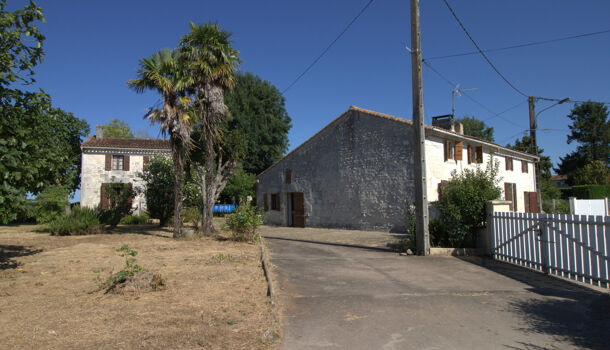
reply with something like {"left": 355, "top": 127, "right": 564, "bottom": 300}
{"left": 0, "top": 226, "right": 279, "bottom": 349}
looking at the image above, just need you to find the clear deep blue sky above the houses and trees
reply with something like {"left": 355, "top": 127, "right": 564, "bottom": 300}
{"left": 9, "top": 0, "right": 610, "bottom": 174}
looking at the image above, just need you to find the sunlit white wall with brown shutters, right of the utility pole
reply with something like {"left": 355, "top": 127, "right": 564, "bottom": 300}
{"left": 425, "top": 135, "right": 536, "bottom": 212}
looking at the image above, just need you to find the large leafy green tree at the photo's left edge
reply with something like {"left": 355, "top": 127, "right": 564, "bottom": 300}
{"left": 0, "top": 0, "right": 89, "bottom": 223}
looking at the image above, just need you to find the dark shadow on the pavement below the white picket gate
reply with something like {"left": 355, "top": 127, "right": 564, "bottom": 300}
{"left": 460, "top": 257, "right": 610, "bottom": 349}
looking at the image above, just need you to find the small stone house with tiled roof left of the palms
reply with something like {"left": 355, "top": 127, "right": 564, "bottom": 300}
{"left": 80, "top": 126, "right": 171, "bottom": 213}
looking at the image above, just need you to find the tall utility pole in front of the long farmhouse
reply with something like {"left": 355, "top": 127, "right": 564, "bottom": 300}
{"left": 411, "top": 0, "right": 430, "bottom": 255}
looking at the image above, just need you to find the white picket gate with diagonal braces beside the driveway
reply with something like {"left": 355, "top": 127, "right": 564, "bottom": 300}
{"left": 491, "top": 212, "right": 610, "bottom": 288}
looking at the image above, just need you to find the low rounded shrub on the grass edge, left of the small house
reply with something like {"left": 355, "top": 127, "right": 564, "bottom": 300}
{"left": 46, "top": 207, "right": 103, "bottom": 236}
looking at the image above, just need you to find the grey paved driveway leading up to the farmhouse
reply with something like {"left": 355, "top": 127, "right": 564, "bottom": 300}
{"left": 266, "top": 232, "right": 610, "bottom": 349}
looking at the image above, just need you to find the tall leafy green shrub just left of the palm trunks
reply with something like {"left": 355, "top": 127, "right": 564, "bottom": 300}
{"left": 138, "top": 156, "right": 175, "bottom": 226}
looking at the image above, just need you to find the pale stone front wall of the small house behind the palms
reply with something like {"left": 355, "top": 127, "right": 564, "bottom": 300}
{"left": 80, "top": 153, "right": 146, "bottom": 213}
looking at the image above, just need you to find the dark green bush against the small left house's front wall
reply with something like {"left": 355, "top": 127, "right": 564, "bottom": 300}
{"left": 100, "top": 183, "right": 135, "bottom": 227}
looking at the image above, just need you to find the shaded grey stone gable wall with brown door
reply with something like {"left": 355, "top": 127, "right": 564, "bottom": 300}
{"left": 257, "top": 110, "right": 413, "bottom": 232}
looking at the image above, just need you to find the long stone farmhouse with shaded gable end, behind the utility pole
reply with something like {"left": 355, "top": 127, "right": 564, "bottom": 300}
{"left": 256, "top": 106, "right": 538, "bottom": 232}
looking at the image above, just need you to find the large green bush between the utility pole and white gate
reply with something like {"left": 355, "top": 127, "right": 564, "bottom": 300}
{"left": 436, "top": 163, "right": 502, "bottom": 248}
